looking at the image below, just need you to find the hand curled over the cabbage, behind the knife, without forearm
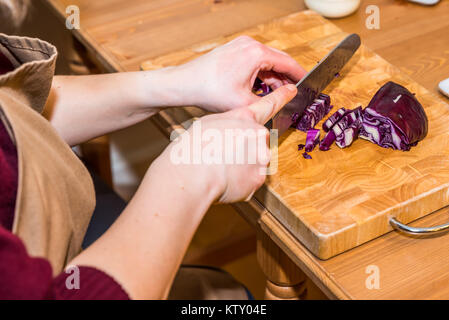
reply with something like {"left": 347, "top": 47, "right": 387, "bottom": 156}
{"left": 174, "top": 36, "right": 305, "bottom": 112}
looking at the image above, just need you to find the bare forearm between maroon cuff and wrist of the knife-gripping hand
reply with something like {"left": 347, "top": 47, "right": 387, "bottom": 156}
{"left": 71, "top": 160, "right": 216, "bottom": 299}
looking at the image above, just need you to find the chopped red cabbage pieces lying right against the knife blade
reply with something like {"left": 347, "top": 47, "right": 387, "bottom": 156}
{"left": 292, "top": 93, "right": 332, "bottom": 132}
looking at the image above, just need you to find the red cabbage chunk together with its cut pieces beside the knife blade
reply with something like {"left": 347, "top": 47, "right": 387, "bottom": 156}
{"left": 300, "top": 82, "right": 428, "bottom": 159}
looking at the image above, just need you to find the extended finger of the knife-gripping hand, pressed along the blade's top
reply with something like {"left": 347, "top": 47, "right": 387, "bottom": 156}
{"left": 248, "top": 84, "right": 298, "bottom": 124}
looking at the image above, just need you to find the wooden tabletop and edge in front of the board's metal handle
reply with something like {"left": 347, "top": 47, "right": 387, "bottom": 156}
{"left": 260, "top": 207, "right": 449, "bottom": 300}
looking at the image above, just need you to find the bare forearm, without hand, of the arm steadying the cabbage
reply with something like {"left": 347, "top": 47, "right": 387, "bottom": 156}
{"left": 45, "top": 68, "right": 183, "bottom": 145}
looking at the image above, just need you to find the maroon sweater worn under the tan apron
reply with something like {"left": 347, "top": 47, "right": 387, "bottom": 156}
{"left": 0, "top": 52, "right": 128, "bottom": 300}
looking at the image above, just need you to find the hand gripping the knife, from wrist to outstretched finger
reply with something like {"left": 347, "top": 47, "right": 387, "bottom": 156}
{"left": 150, "top": 84, "right": 297, "bottom": 203}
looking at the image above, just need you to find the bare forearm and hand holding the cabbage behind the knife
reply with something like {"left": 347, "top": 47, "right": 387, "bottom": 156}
{"left": 45, "top": 37, "right": 305, "bottom": 146}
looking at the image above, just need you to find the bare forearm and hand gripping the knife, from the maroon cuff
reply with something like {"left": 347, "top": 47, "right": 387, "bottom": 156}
{"left": 71, "top": 85, "right": 296, "bottom": 299}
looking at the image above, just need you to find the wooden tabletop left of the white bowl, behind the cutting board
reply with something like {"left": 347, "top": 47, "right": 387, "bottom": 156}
{"left": 43, "top": 0, "right": 304, "bottom": 72}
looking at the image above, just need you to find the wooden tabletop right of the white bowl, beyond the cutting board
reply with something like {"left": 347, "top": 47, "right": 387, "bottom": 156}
{"left": 331, "top": 0, "right": 449, "bottom": 95}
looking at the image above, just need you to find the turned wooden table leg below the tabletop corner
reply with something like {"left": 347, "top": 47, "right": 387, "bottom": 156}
{"left": 257, "top": 230, "right": 307, "bottom": 300}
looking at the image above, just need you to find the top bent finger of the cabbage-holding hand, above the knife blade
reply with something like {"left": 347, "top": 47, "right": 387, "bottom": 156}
{"left": 261, "top": 47, "right": 307, "bottom": 82}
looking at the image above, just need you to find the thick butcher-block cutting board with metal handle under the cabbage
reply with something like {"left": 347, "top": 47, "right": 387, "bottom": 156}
{"left": 142, "top": 11, "right": 449, "bottom": 259}
